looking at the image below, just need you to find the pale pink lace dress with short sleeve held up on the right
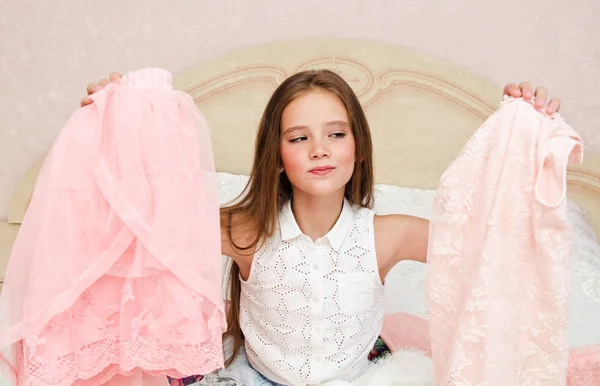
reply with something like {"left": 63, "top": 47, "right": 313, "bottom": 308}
{"left": 427, "top": 99, "right": 582, "bottom": 386}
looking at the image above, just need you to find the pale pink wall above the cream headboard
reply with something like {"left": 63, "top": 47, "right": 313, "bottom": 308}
{"left": 0, "top": 0, "right": 600, "bottom": 219}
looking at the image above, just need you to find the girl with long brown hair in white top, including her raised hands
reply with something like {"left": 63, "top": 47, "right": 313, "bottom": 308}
{"left": 81, "top": 70, "right": 560, "bottom": 385}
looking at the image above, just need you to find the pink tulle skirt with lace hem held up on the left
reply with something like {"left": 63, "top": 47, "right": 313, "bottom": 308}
{"left": 0, "top": 69, "right": 225, "bottom": 385}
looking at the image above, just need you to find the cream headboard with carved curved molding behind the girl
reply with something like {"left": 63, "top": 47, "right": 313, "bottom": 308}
{"left": 0, "top": 39, "right": 600, "bottom": 285}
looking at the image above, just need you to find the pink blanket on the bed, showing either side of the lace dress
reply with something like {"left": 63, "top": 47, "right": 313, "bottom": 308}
{"left": 380, "top": 312, "right": 600, "bottom": 386}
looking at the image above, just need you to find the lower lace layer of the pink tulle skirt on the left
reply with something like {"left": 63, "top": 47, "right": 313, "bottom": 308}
{"left": 17, "top": 276, "right": 224, "bottom": 386}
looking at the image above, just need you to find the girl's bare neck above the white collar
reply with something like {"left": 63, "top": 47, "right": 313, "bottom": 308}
{"left": 292, "top": 189, "right": 344, "bottom": 241}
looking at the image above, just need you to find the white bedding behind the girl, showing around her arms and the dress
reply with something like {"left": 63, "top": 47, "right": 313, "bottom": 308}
{"left": 218, "top": 173, "right": 600, "bottom": 347}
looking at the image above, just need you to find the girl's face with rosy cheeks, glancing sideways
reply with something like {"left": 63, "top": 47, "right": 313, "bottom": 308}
{"left": 280, "top": 90, "right": 355, "bottom": 196}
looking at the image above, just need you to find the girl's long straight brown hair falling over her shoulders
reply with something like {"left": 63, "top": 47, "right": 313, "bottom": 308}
{"left": 221, "top": 70, "right": 374, "bottom": 366}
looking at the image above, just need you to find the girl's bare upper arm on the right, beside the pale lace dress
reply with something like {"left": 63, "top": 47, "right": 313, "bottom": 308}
{"left": 373, "top": 214, "right": 429, "bottom": 279}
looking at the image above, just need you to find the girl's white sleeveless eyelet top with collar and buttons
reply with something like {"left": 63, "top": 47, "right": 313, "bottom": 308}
{"left": 240, "top": 200, "right": 383, "bottom": 385}
